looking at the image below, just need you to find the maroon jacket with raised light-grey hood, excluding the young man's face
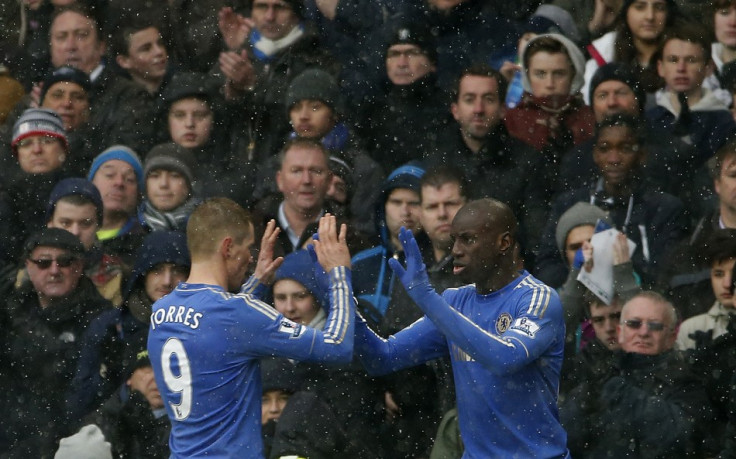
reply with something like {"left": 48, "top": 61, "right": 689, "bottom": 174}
{"left": 504, "top": 34, "right": 595, "bottom": 155}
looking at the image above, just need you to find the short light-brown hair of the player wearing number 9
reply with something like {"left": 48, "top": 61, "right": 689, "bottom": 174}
{"left": 187, "top": 198, "right": 253, "bottom": 262}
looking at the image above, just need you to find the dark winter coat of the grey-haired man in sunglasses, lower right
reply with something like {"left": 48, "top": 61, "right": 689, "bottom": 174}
{"left": 560, "top": 351, "right": 712, "bottom": 458}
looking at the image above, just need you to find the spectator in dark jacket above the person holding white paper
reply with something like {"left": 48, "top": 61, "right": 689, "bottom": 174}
{"left": 536, "top": 115, "right": 687, "bottom": 287}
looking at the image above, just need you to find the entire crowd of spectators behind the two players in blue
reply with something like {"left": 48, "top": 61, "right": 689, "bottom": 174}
{"left": 0, "top": 0, "right": 736, "bottom": 459}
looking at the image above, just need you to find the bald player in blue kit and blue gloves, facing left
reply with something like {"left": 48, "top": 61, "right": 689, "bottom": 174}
{"left": 355, "top": 199, "right": 569, "bottom": 458}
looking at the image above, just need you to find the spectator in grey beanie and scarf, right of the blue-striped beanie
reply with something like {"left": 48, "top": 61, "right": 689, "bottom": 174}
{"left": 138, "top": 142, "right": 201, "bottom": 232}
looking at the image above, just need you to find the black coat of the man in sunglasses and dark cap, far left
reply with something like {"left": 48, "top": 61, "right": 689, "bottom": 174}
{"left": 0, "top": 277, "right": 111, "bottom": 457}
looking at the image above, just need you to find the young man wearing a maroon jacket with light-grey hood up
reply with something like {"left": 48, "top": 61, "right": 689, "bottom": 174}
{"left": 504, "top": 34, "right": 594, "bottom": 166}
